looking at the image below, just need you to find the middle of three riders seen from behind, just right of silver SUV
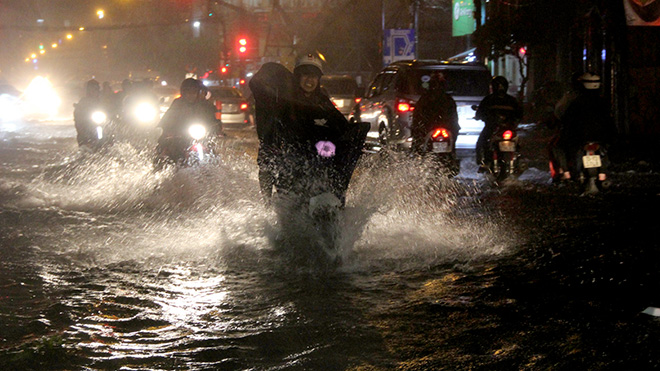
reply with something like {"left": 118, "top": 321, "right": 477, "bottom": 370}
{"left": 475, "top": 76, "right": 523, "bottom": 171}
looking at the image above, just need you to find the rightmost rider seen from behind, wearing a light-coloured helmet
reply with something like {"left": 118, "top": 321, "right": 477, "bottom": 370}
{"left": 555, "top": 72, "right": 615, "bottom": 181}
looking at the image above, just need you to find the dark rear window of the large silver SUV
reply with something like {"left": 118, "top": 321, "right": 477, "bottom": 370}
{"left": 399, "top": 69, "right": 490, "bottom": 97}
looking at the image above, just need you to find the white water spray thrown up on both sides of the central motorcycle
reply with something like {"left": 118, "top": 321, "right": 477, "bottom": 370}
{"left": 6, "top": 143, "right": 516, "bottom": 270}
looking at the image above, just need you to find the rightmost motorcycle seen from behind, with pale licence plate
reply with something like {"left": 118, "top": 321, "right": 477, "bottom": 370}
{"left": 575, "top": 142, "right": 608, "bottom": 194}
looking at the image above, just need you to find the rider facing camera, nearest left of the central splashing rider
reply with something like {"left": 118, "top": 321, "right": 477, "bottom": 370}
{"left": 157, "top": 78, "right": 222, "bottom": 164}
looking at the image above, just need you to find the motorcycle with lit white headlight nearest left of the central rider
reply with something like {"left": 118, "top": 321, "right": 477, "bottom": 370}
{"left": 155, "top": 122, "right": 217, "bottom": 169}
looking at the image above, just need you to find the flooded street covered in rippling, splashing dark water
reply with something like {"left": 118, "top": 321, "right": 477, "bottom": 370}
{"left": 0, "top": 120, "right": 660, "bottom": 370}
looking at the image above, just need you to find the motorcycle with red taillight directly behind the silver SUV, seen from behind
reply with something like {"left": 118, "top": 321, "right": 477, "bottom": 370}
{"left": 421, "top": 125, "right": 460, "bottom": 177}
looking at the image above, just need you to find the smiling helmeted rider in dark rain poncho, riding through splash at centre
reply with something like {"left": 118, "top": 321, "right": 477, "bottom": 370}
{"left": 250, "top": 54, "right": 368, "bottom": 206}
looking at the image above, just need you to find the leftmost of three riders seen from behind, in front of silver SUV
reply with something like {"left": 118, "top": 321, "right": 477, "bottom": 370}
{"left": 411, "top": 72, "right": 461, "bottom": 154}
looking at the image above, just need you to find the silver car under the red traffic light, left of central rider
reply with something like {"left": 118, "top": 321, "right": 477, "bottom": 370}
{"left": 209, "top": 86, "right": 251, "bottom": 129}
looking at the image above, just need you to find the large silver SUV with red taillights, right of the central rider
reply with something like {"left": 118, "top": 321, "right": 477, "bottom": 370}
{"left": 349, "top": 60, "right": 491, "bottom": 150}
